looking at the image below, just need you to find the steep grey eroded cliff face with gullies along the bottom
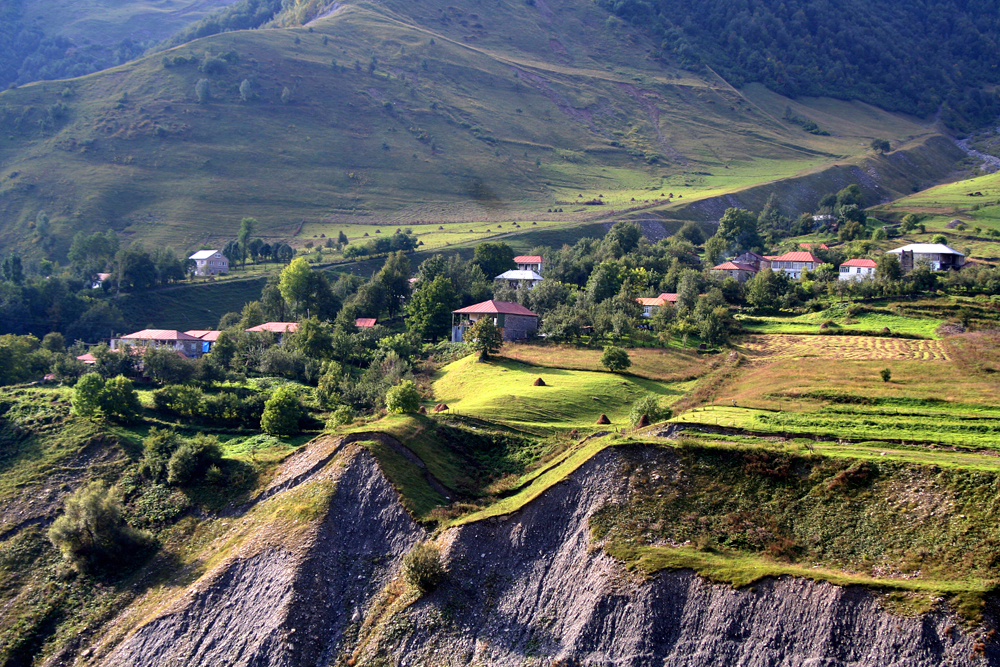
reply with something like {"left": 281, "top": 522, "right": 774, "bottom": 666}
{"left": 91, "top": 440, "right": 1000, "bottom": 667}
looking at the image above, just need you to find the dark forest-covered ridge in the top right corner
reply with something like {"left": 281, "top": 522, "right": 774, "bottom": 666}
{"left": 600, "top": 0, "right": 1000, "bottom": 132}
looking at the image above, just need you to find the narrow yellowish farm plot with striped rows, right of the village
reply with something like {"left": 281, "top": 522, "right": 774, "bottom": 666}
{"left": 743, "top": 334, "right": 949, "bottom": 362}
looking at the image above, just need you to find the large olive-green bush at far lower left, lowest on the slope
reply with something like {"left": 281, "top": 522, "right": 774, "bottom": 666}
{"left": 49, "top": 481, "right": 150, "bottom": 572}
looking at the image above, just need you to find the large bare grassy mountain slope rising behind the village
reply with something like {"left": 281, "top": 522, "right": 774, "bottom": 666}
{"left": 0, "top": 0, "right": 952, "bottom": 257}
